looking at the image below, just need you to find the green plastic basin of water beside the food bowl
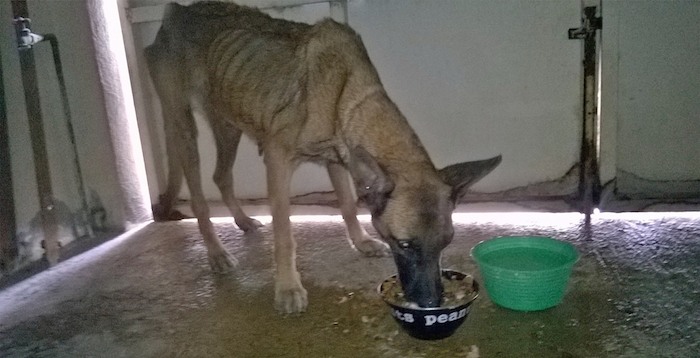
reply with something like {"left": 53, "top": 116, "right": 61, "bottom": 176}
{"left": 471, "top": 236, "right": 579, "bottom": 311}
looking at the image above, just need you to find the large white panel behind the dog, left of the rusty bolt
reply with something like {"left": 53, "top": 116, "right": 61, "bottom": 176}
{"left": 132, "top": 0, "right": 581, "bottom": 199}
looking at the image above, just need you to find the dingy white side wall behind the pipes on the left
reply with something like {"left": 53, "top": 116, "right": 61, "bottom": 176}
{"left": 0, "top": 0, "right": 131, "bottom": 229}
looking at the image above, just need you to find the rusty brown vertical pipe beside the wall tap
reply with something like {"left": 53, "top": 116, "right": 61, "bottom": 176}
{"left": 12, "top": 0, "right": 59, "bottom": 265}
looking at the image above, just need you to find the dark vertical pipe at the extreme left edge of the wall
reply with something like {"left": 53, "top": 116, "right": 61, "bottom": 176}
{"left": 0, "top": 44, "right": 17, "bottom": 275}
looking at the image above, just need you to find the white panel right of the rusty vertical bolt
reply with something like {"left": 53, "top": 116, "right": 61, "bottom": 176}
{"left": 602, "top": 0, "right": 700, "bottom": 197}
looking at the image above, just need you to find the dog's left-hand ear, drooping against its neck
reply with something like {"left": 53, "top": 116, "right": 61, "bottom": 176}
{"left": 348, "top": 146, "right": 394, "bottom": 216}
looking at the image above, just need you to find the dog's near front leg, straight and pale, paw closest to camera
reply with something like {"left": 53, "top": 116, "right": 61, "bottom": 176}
{"left": 264, "top": 143, "right": 308, "bottom": 313}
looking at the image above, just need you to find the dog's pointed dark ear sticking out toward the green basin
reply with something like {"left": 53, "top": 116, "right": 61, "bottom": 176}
{"left": 439, "top": 155, "right": 501, "bottom": 202}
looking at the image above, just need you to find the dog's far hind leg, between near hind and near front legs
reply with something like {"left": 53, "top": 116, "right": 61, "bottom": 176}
{"left": 211, "top": 117, "right": 262, "bottom": 232}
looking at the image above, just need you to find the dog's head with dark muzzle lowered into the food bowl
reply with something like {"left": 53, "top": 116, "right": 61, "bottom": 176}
{"left": 350, "top": 147, "right": 501, "bottom": 307}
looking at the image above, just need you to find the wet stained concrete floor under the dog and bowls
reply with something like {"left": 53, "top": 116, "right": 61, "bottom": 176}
{"left": 0, "top": 206, "right": 700, "bottom": 358}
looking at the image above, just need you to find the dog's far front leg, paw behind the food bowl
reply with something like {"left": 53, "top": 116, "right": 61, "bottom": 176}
{"left": 328, "top": 163, "right": 389, "bottom": 256}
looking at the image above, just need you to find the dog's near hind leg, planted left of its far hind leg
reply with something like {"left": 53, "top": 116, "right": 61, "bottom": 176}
{"left": 176, "top": 108, "right": 236, "bottom": 272}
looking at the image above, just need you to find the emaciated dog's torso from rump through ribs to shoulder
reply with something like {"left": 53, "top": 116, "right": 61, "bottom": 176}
{"left": 146, "top": 2, "right": 381, "bottom": 155}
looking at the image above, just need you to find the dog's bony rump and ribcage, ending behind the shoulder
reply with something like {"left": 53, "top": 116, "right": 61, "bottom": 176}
{"left": 146, "top": 2, "right": 308, "bottom": 137}
